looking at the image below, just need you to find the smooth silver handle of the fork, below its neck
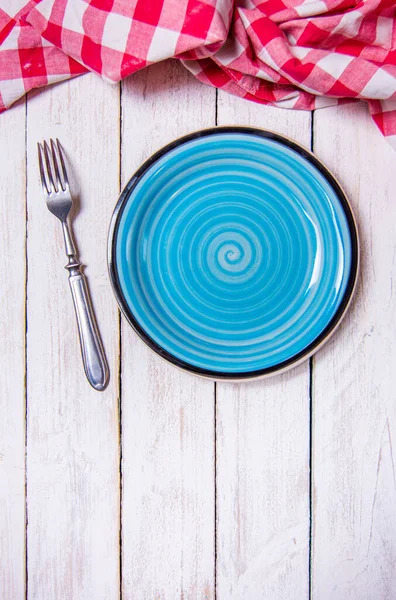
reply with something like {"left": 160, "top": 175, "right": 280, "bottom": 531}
{"left": 66, "top": 263, "right": 109, "bottom": 391}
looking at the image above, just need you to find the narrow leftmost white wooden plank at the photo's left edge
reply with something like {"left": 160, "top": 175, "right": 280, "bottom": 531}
{"left": 0, "top": 103, "right": 26, "bottom": 600}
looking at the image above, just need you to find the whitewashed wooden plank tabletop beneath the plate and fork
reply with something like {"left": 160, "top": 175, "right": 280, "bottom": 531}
{"left": 0, "top": 62, "right": 396, "bottom": 600}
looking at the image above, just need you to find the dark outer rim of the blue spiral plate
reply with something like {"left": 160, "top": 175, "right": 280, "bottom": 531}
{"left": 108, "top": 126, "right": 359, "bottom": 380}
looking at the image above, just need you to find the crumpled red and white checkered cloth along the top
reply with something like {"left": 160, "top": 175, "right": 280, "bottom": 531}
{"left": 0, "top": 0, "right": 396, "bottom": 148}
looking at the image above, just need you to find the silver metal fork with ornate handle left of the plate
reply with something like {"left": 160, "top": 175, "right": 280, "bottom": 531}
{"left": 37, "top": 140, "right": 109, "bottom": 391}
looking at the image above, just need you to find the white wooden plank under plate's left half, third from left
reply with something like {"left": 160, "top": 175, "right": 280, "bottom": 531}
{"left": 122, "top": 62, "right": 215, "bottom": 600}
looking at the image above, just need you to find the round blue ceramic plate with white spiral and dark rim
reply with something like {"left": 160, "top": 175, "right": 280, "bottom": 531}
{"left": 109, "top": 127, "right": 358, "bottom": 379}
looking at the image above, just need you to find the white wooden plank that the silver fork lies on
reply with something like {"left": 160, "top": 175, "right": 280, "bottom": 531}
{"left": 27, "top": 75, "right": 119, "bottom": 600}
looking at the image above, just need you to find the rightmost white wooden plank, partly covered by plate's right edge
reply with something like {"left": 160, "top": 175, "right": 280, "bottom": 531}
{"left": 313, "top": 104, "right": 396, "bottom": 600}
